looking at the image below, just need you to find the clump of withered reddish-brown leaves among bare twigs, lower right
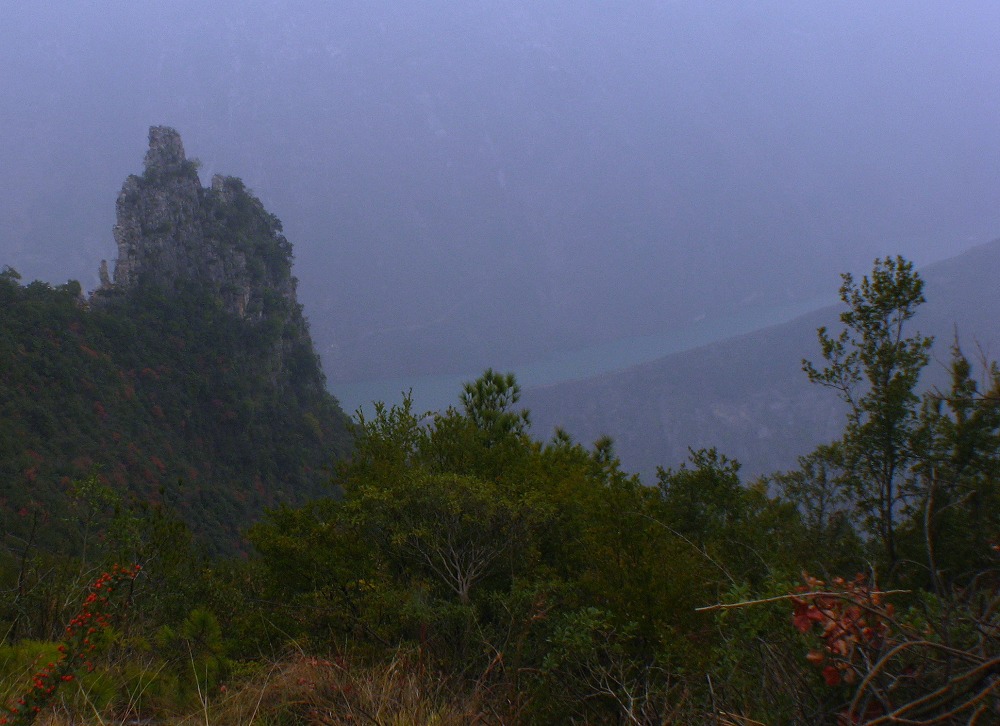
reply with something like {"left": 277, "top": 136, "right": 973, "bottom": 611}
{"left": 792, "top": 574, "right": 893, "bottom": 686}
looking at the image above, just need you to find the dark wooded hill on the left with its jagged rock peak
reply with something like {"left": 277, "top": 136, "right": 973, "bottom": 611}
{"left": 0, "top": 127, "right": 348, "bottom": 551}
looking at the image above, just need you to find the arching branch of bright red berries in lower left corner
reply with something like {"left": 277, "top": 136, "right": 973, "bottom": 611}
{"left": 0, "top": 565, "right": 142, "bottom": 726}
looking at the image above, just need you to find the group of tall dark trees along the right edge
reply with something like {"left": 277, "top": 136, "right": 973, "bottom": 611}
{"left": 796, "top": 258, "right": 1000, "bottom": 592}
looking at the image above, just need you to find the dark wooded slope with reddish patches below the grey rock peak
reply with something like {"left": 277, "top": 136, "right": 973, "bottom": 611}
{"left": 0, "top": 268, "right": 348, "bottom": 552}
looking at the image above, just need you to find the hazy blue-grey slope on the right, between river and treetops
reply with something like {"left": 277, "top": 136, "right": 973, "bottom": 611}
{"left": 523, "top": 240, "right": 1000, "bottom": 484}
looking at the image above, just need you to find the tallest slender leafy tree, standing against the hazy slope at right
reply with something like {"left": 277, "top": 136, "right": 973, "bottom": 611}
{"left": 802, "top": 257, "right": 933, "bottom": 571}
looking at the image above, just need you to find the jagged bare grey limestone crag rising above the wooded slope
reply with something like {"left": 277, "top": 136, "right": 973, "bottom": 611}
{"left": 94, "top": 126, "right": 324, "bottom": 396}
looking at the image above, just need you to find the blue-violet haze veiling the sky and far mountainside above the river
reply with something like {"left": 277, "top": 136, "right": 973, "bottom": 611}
{"left": 0, "top": 0, "right": 1000, "bottom": 380}
